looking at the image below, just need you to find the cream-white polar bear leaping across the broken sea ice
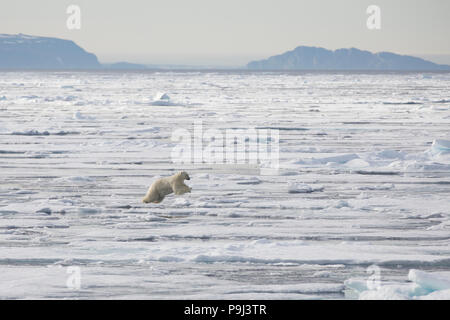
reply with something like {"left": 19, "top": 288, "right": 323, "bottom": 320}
{"left": 142, "top": 171, "right": 192, "bottom": 203}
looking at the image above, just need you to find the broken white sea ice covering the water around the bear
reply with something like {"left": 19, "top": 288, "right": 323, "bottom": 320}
{"left": 0, "top": 72, "right": 450, "bottom": 299}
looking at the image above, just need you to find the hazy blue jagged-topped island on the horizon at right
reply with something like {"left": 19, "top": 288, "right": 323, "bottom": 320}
{"left": 247, "top": 46, "right": 450, "bottom": 71}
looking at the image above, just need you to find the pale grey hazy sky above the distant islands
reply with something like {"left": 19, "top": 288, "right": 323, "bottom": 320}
{"left": 0, "top": 0, "right": 450, "bottom": 66}
